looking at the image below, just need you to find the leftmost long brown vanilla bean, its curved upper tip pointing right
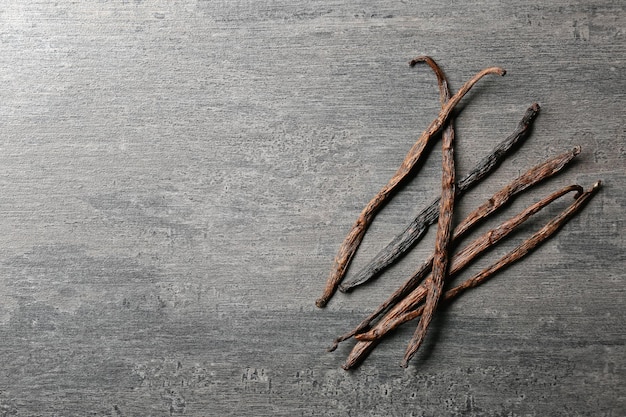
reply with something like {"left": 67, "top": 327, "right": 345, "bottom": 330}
{"left": 315, "top": 67, "right": 506, "bottom": 308}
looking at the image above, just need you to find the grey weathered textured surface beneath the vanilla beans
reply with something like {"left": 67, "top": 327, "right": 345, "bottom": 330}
{"left": 0, "top": 0, "right": 626, "bottom": 417}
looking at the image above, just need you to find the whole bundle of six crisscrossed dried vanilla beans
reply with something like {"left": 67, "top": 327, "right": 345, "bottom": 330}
{"left": 316, "top": 56, "right": 600, "bottom": 369}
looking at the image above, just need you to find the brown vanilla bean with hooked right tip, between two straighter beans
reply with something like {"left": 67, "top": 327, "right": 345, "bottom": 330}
{"left": 343, "top": 186, "right": 582, "bottom": 369}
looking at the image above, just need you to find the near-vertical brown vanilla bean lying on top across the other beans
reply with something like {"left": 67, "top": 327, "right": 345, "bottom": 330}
{"left": 404, "top": 55, "right": 455, "bottom": 370}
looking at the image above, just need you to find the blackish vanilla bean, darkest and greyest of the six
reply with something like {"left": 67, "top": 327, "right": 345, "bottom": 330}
{"left": 339, "top": 103, "right": 539, "bottom": 292}
